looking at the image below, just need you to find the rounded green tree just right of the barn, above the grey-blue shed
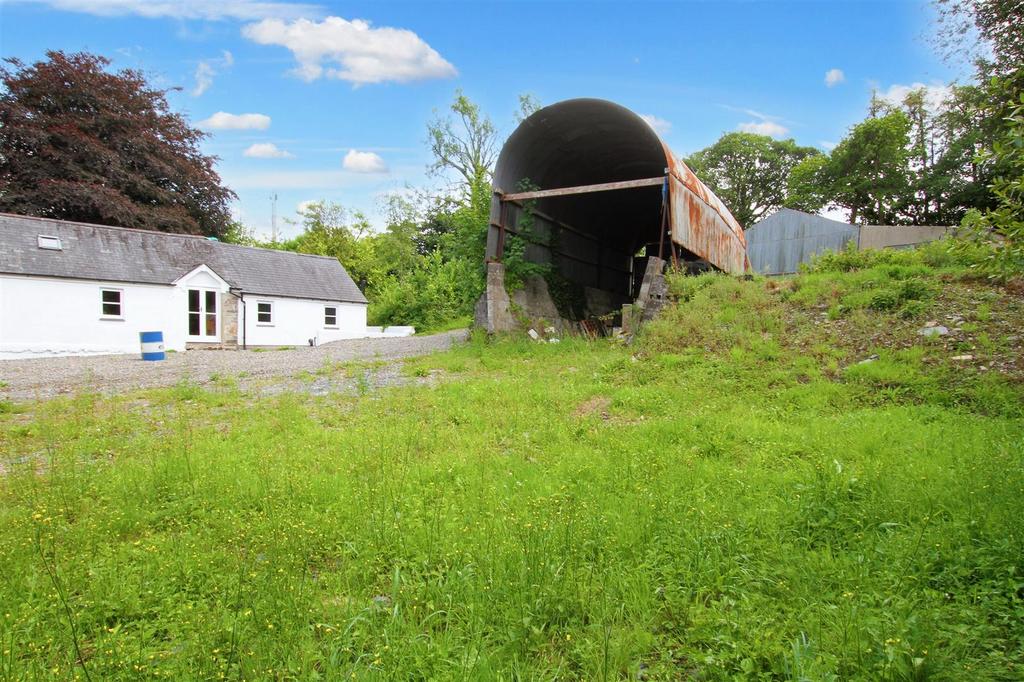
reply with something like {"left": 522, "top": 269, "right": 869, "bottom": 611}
{"left": 686, "top": 132, "right": 820, "bottom": 229}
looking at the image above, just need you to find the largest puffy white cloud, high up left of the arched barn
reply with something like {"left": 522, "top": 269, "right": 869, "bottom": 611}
{"left": 242, "top": 16, "right": 458, "bottom": 85}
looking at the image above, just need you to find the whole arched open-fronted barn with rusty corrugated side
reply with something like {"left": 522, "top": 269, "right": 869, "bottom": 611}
{"left": 477, "top": 98, "right": 748, "bottom": 329}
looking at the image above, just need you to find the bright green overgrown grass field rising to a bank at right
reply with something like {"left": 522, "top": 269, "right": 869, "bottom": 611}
{"left": 0, "top": 253, "right": 1024, "bottom": 680}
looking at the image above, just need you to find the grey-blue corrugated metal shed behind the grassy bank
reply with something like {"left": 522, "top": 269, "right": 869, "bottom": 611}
{"left": 746, "top": 209, "right": 859, "bottom": 274}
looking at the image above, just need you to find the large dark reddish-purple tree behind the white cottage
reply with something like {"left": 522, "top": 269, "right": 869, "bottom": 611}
{"left": 0, "top": 51, "right": 234, "bottom": 237}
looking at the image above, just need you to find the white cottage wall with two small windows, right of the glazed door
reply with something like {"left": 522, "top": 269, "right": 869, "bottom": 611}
{"left": 240, "top": 294, "right": 367, "bottom": 347}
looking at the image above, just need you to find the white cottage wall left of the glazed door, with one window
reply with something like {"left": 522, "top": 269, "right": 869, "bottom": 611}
{"left": 0, "top": 274, "right": 186, "bottom": 359}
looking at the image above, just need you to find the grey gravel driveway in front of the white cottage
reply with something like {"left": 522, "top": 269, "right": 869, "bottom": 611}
{"left": 0, "top": 330, "right": 468, "bottom": 400}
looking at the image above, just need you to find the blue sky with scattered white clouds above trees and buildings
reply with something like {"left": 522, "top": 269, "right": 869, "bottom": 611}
{"left": 0, "top": 0, "right": 964, "bottom": 235}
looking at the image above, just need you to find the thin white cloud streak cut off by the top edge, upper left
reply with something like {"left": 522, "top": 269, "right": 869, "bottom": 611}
{"left": 12, "top": 0, "right": 322, "bottom": 22}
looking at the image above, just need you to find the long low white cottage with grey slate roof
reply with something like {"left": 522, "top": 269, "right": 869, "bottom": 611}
{"left": 0, "top": 214, "right": 367, "bottom": 359}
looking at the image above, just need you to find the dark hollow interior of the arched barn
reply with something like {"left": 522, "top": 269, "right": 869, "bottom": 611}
{"left": 487, "top": 99, "right": 669, "bottom": 305}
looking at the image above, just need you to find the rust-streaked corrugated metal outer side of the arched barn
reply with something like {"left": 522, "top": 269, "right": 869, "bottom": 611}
{"left": 665, "top": 145, "right": 749, "bottom": 274}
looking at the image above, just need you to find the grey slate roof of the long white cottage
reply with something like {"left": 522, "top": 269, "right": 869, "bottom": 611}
{"left": 0, "top": 213, "right": 367, "bottom": 303}
